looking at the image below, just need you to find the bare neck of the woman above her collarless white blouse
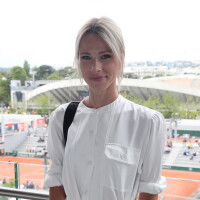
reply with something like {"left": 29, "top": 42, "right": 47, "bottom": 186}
{"left": 84, "top": 89, "right": 118, "bottom": 108}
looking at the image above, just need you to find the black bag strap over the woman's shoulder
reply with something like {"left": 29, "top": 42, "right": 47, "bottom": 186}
{"left": 63, "top": 102, "right": 79, "bottom": 145}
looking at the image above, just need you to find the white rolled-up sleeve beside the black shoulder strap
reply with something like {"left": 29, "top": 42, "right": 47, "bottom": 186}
{"left": 44, "top": 106, "right": 65, "bottom": 188}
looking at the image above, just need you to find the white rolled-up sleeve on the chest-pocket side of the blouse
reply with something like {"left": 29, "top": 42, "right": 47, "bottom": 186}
{"left": 139, "top": 112, "right": 166, "bottom": 194}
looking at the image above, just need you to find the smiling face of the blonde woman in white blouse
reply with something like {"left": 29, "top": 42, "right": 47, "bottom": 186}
{"left": 79, "top": 34, "right": 120, "bottom": 92}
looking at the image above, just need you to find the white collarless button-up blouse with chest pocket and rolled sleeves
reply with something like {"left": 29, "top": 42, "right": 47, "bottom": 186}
{"left": 45, "top": 95, "right": 166, "bottom": 200}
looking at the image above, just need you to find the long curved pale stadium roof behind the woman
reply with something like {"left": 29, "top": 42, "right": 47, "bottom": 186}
{"left": 26, "top": 78, "right": 200, "bottom": 106}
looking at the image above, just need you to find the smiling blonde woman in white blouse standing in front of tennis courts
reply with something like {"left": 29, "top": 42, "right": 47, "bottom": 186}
{"left": 45, "top": 17, "right": 166, "bottom": 200}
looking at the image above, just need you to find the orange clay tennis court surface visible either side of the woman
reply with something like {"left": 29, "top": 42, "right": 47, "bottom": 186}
{"left": 0, "top": 156, "right": 200, "bottom": 200}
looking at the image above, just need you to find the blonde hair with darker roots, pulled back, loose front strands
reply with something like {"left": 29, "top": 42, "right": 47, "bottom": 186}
{"left": 74, "top": 17, "right": 125, "bottom": 83}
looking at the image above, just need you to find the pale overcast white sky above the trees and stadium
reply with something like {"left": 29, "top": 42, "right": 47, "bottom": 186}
{"left": 0, "top": 0, "right": 200, "bottom": 68}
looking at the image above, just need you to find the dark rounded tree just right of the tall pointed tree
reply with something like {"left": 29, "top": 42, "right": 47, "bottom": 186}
{"left": 36, "top": 65, "right": 55, "bottom": 80}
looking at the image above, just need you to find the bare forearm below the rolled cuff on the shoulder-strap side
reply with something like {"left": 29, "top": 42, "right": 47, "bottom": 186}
{"left": 49, "top": 186, "right": 66, "bottom": 200}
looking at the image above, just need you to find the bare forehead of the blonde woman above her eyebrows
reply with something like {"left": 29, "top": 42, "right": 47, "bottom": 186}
{"left": 79, "top": 33, "right": 111, "bottom": 52}
